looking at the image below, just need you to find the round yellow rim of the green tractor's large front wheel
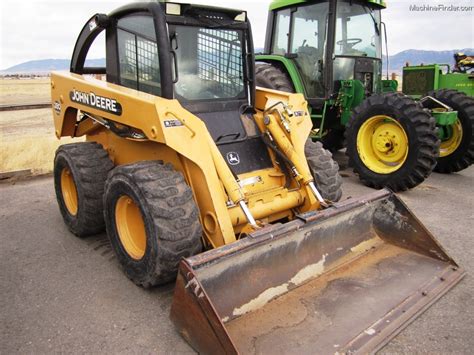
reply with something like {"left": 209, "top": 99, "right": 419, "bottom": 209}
{"left": 357, "top": 115, "right": 408, "bottom": 174}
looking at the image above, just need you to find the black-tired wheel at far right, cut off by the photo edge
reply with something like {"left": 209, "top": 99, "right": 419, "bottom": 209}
{"left": 428, "top": 89, "right": 474, "bottom": 174}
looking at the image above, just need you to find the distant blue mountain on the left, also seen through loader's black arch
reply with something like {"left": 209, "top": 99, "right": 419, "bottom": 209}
{"left": 0, "top": 58, "right": 105, "bottom": 74}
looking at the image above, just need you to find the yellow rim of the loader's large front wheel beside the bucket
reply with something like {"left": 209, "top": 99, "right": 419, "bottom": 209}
{"left": 115, "top": 196, "right": 146, "bottom": 260}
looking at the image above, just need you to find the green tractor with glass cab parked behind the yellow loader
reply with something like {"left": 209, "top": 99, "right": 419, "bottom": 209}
{"left": 256, "top": 0, "right": 440, "bottom": 191}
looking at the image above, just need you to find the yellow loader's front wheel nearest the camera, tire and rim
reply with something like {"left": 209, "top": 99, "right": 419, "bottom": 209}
{"left": 104, "top": 161, "right": 202, "bottom": 288}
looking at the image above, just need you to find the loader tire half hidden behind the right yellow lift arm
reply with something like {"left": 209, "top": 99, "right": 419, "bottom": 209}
{"left": 305, "top": 139, "right": 342, "bottom": 202}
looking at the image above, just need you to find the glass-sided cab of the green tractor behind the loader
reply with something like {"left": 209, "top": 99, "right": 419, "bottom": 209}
{"left": 259, "top": 0, "right": 384, "bottom": 104}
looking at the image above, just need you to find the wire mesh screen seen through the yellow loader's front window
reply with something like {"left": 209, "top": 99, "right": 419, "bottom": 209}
{"left": 198, "top": 28, "right": 244, "bottom": 97}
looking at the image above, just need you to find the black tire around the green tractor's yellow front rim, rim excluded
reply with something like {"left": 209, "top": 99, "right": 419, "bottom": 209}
{"left": 346, "top": 93, "right": 440, "bottom": 191}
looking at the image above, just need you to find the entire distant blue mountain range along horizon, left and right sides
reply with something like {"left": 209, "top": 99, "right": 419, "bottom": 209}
{"left": 0, "top": 48, "right": 474, "bottom": 74}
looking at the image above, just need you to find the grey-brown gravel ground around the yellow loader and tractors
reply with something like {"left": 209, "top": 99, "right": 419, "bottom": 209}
{"left": 0, "top": 160, "right": 474, "bottom": 354}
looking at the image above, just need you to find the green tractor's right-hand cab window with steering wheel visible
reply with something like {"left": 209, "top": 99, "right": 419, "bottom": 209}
{"left": 335, "top": 1, "right": 382, "bottom": 58}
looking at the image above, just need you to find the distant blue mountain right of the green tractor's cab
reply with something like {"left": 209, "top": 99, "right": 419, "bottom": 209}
{"left": 384, "top": 48, "right": 474, "bottom": 73}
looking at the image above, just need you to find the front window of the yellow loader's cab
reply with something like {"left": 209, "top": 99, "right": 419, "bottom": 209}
{"left": 171, "top": 26, "right": 245, "bottom": 100}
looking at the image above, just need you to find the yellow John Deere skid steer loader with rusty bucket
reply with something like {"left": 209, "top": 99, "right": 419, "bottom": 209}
{"left": 51, "top": 2, "right": 464, "bottom": 354}
